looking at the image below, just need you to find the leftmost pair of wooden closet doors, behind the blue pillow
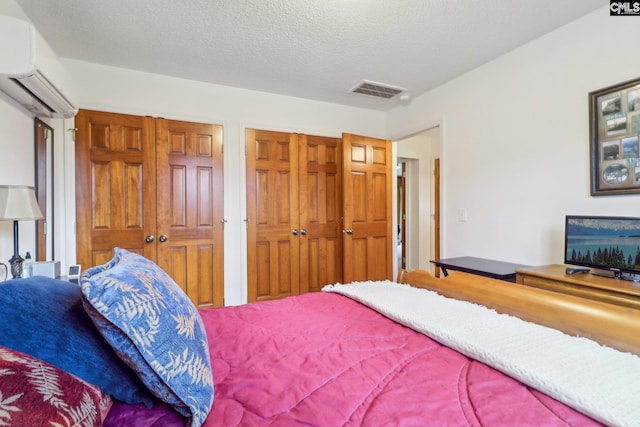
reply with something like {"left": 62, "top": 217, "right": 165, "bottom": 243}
{"left": 75, "top": 110, "right": 224, "bottom": 307}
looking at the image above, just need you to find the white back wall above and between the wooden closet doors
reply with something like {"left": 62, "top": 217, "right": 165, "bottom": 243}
{"left": 63, "top": 60, "right": 386, "bottom": 304}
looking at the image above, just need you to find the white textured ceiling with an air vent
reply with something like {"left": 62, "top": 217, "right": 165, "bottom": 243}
{"left": 16, "top": 0, "right": 609, "bottom": 110}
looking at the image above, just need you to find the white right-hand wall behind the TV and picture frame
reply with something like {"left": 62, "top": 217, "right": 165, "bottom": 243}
{"left": 388, "top": 7, "right": 640, "bottom": 265}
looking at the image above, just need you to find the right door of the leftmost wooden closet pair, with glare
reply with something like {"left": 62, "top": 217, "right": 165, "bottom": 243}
{"left": 155, "top": 119, "right": 224, "bottom": 307}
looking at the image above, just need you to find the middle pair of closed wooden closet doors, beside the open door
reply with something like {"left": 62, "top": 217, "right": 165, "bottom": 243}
{"left": 246, "top": 129, "right": 343, "bottom": 302}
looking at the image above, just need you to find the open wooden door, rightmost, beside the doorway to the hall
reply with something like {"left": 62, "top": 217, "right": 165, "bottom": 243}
{"left": 342, "top": 133, "right": 395, "bottom": 282}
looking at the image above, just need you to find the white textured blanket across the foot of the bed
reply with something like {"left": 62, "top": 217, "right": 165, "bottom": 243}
{"left": 323, "top": 281, "right": 640, "bottom": 426}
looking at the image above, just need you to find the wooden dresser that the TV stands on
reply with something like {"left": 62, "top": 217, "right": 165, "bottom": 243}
{"left": 516, "top": 264, "right": 640, "bottom": 310}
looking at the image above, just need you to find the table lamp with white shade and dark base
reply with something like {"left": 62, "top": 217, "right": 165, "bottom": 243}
{"left": 0, "top": 185, "right": 44, "bottom": 279}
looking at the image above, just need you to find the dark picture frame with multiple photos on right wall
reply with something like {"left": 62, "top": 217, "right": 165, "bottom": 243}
{"left": 589, "top": 78, "right": 640, "bottom": 196}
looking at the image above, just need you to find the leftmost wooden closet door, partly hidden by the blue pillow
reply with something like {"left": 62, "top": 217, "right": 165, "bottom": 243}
{"left": 75, "top": 110, "right": 156, "bottom": 268}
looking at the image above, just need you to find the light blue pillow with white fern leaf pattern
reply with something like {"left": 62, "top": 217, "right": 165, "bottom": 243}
{"left": 80, "top": 248, "right": 213, "bottom": 426}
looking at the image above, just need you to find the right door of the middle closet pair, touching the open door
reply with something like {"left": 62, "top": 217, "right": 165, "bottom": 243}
{"left": 298, "top": 135, "right": 342, "bottom": 293}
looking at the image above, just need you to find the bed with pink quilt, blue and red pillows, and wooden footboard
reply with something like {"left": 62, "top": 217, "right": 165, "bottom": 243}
{"left": 0, "top": 249, "right": 640, "bottom": 427}
